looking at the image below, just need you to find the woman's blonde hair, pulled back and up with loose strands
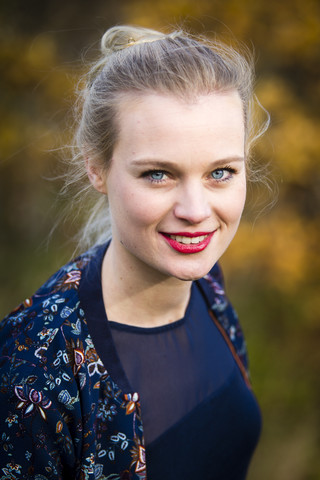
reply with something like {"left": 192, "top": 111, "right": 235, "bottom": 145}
{"left": 65, "top": 26, "right": 269, "bottom": 248}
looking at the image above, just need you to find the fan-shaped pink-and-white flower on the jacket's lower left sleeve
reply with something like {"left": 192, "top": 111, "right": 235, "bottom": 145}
{"left": 14, "top": 385, "right": 52, "bottom": 420}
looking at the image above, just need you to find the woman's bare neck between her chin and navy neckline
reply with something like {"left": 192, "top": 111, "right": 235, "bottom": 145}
{"left": 102, "top": 242, "right": 191, "bottom": 328}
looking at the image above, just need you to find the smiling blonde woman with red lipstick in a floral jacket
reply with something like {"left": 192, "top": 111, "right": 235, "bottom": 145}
{"left": 0, "top": 27, "right": 268, "bottom": 480}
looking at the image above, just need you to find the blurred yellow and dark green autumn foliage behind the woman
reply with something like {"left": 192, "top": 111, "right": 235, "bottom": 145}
{"left": 0, "top": 0, "right": 320, "bottom": 480}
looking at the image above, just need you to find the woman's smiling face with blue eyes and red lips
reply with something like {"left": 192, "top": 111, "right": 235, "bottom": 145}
{"left": 105, "top": 91, "right": 246, "bottom": 280}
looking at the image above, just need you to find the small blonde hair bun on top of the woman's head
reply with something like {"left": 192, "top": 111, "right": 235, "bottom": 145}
{"left": 101, "top": 25, "right": 172, "bottom": 55}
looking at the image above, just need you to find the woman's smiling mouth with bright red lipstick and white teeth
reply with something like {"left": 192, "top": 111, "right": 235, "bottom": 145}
{"left": 160, "top": 231, "right": 215, "bottom": 253}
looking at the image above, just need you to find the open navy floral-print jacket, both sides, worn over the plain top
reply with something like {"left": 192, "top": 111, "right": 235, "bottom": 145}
{"left": 0, "top": 246, "right": 248, "bottom": 480}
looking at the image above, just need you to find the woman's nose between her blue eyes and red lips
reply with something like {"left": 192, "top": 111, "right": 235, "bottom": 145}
{"left": 174, "top": 182, "right": 212, "bottom": 224}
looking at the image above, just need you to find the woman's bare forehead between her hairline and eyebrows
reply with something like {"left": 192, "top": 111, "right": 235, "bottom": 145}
{"left": 115, "top": 91, "right": 244, "bottom": 160}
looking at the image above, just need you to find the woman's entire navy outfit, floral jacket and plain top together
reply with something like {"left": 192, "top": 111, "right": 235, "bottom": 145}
{"left": 0, "top": 244, "right": 260, "bottom": 480}
